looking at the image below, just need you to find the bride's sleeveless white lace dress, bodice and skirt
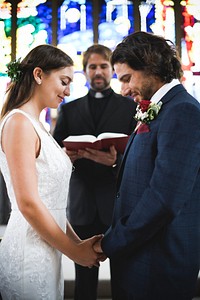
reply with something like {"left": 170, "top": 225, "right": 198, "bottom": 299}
{"left": 0, "top": 109, "right": 72, "bottom": 300}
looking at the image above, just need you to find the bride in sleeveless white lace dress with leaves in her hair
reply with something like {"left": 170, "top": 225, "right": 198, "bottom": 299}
{"left": 0, "top": 45, "right": 104, "bottom": 300}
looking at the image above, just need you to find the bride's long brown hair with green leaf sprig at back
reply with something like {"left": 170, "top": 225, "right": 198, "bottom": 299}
{"left": 1, "top": 44, "right": 73, "bottom": 118}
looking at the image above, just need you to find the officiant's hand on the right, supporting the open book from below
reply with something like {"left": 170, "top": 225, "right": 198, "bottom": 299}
{"left": 78, "top": 146, "right": 117, "bottom": 166}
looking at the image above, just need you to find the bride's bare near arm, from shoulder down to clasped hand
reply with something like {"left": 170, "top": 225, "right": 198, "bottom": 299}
{"left": 2, "top": 114, "right": 99, "bottom": 266}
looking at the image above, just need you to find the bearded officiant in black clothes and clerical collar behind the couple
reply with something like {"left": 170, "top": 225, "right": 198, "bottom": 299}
{"left": 53, "top": 44, "right": 136, "bottom": 300}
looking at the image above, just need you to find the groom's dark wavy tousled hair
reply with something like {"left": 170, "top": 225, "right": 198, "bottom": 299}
{"left": 111, "top": 31, "right": 183, "bottom": 83}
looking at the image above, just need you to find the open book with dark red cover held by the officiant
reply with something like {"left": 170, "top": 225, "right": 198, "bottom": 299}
{"left": 63, "top": 132, "right": 129, "bottom": 153}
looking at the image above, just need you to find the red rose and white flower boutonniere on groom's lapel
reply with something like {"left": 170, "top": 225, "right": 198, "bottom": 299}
{"left": 134, "top": 100, "right": 162, "bottom": 123}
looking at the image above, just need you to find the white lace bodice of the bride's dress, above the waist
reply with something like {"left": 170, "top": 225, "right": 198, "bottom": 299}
{"left": 0, "top": 109, "right": 72, "bottom": 210}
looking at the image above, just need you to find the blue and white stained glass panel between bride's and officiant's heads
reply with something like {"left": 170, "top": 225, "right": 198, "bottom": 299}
{"left": 57, "top": 0, "right": 94, "bottom": 101}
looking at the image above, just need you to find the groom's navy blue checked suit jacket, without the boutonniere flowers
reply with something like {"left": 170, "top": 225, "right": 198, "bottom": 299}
{"left": 102, "top": 84, "right": 200, "bottom": 300}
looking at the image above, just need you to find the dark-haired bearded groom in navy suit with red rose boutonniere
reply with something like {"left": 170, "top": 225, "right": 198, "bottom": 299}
{"left": 95, "top": 32, "right": 200, "bottom": 300}
